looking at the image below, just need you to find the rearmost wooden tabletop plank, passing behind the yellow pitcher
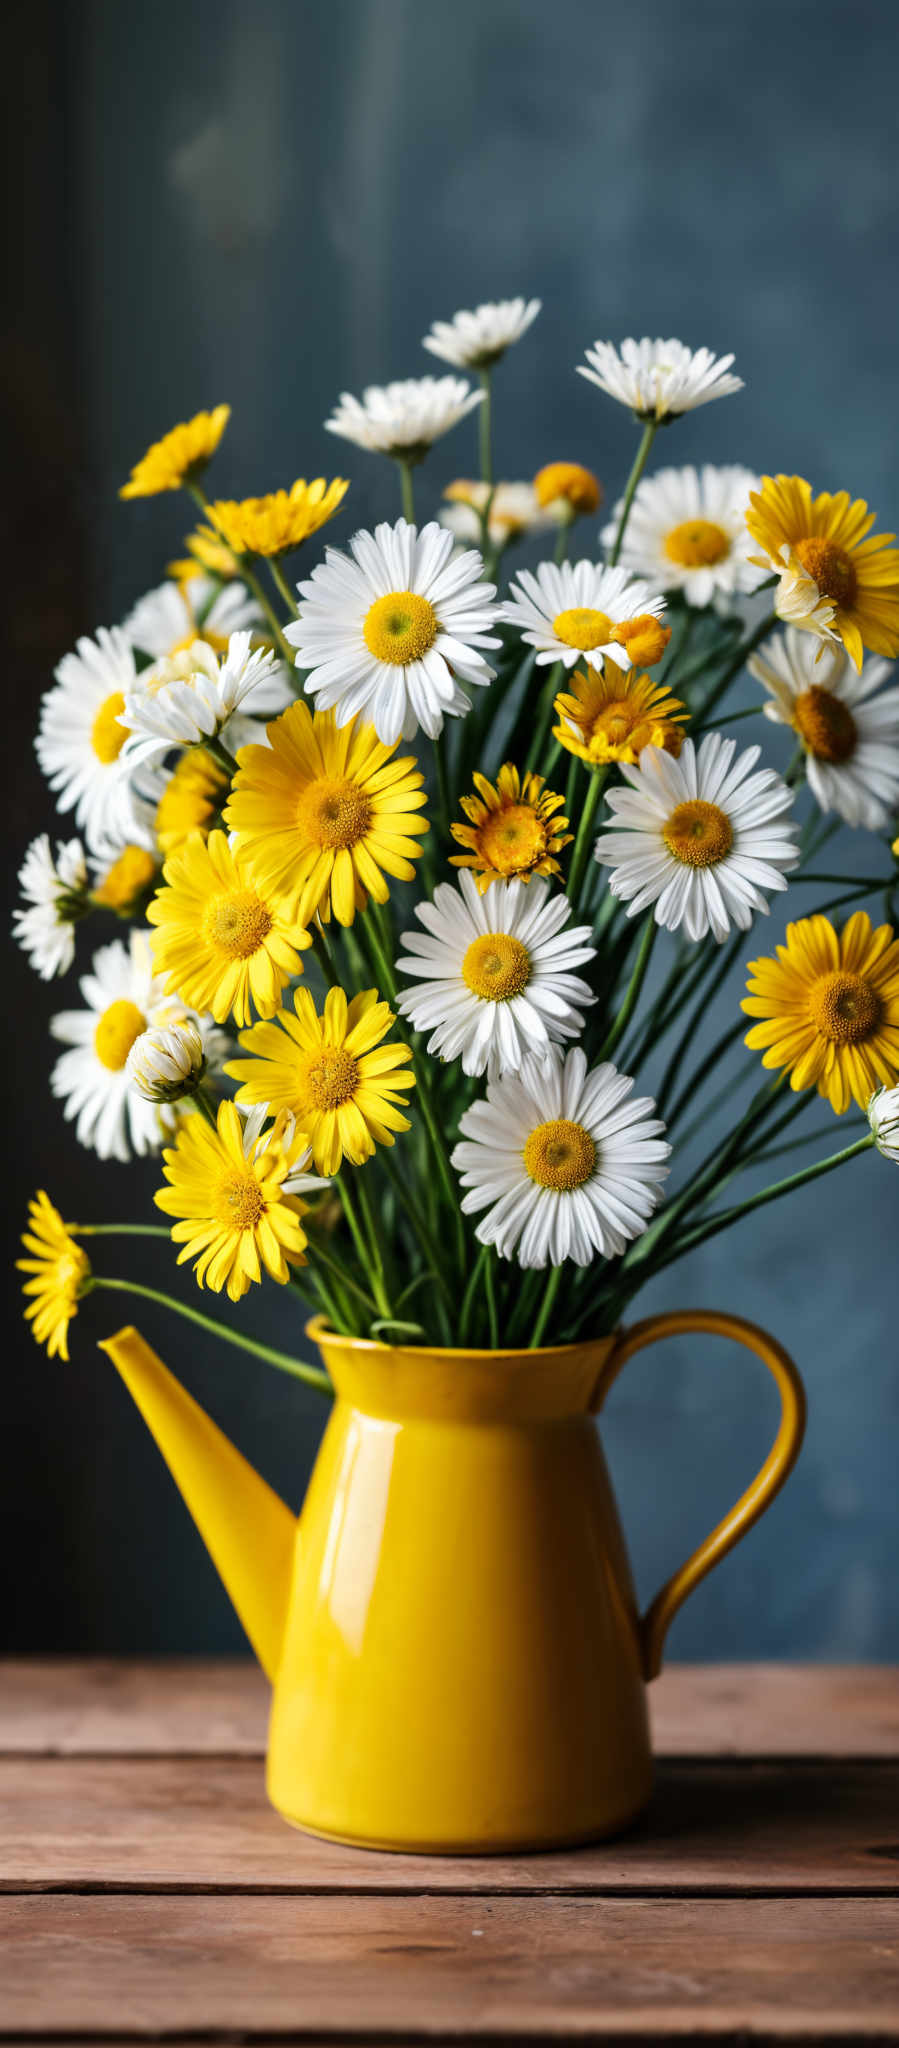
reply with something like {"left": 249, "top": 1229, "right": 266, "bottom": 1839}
{"left": 0, "top": 1657, "right": 899, "bottom": 1757}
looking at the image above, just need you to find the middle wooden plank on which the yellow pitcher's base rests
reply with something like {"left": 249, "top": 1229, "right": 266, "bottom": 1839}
{"left": 0, "top": 1757, "right": 899, "bottom": 1896}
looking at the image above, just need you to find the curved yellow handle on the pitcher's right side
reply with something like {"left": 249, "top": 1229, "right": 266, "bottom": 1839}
{"left": 590, "top": 1309, "right": 805, "bottom": 1679}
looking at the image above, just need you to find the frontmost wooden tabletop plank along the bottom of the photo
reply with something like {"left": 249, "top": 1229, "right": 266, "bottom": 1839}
{"left": 0, "top": 1896, "right": 899, "bottom": 2042}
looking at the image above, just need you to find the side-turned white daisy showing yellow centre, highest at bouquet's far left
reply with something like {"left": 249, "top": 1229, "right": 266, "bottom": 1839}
{"left": 35, "top": 627, "right": 137, "bottom": 852}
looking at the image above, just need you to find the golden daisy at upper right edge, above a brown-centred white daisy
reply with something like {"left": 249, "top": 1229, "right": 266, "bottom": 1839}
{"left": 745, "top": 475, "right": 899, "bottom": 670}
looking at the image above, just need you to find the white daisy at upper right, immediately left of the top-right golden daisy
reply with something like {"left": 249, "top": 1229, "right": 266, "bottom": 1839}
{"left": 600, "top": 463, "right": 764, "bottom": 604}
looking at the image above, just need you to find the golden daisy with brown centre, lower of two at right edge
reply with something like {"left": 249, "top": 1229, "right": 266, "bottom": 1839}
{"left": 741, "top": 909, "right": 899, "bottom": 1116}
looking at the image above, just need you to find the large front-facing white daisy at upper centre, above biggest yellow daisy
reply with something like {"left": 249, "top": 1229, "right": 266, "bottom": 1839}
{"left": 285, "top": 518, "right": 500, "bottom": 748}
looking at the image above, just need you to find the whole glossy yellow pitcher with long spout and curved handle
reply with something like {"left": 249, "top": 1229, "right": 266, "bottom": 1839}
{"left": 104, "top": 1311, "right": 805, "bottom": 1853}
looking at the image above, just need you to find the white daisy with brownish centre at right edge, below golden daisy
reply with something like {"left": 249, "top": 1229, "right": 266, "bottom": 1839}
{"left": 747, "top": 627, "right": 899, "bottom": 831}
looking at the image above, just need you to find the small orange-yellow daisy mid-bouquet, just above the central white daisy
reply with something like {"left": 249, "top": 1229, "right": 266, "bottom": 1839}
{"left": 451, "top": 762, "right": 571, "bottom": 893}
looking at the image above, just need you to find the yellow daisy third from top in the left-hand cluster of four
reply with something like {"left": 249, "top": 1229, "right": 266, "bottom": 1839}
{"left": 225, "top": 989, "right": 416, "bottom": 1176}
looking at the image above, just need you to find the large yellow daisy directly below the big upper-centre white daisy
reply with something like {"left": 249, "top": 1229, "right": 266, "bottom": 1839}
{"left": 225, "top": 702, "right": 428, "bottom": 924}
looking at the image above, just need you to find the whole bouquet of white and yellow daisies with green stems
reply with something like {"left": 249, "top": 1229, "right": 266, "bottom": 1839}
{"left": 16, "top": 299, "right": 899, "bottom": 1386}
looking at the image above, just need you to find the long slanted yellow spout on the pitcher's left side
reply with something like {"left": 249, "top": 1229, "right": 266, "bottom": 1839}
{"left": 100, "top": 1329, "right": 297, "bottom": 1683}
